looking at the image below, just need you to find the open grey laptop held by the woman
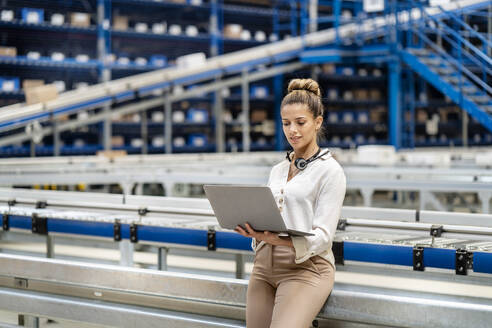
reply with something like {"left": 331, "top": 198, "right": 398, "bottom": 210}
{"left": 203, "top": 185, "right": 314, "bottom": 236}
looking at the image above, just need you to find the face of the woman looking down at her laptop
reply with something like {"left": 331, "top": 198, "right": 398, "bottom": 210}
{"left": 280, "top": 104, "right": 323, "bottom": 150}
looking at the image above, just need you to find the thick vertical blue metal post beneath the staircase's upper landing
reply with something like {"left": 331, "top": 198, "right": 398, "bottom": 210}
{"left": 388, "top": 61, "right": 402, "bottom": 149}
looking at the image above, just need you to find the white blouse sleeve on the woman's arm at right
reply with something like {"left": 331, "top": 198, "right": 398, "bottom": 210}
{"left": 291, "top": 167, "right": 346, "bottom": 263}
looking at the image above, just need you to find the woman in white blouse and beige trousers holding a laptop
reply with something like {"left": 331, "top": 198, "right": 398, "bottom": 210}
{"left": 235, "top": 79, "right": 345, "bottom": 328}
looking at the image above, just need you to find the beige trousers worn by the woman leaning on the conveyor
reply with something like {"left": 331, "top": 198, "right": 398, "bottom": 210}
{"left": 246, "top": 244, "right": 335, "bottom": 328}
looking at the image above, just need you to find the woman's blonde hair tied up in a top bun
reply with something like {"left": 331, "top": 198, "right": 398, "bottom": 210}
{"left": 280, "top": 79, "right": 324, "bottom": 140}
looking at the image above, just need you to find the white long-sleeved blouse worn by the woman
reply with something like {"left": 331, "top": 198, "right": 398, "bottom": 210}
{"left": 252, "top": 149, "right": 346, "bottom": 266}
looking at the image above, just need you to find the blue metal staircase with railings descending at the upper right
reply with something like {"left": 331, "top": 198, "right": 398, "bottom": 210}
{"left": 399, "top": 2, "right": 492, "bottom": 132}
